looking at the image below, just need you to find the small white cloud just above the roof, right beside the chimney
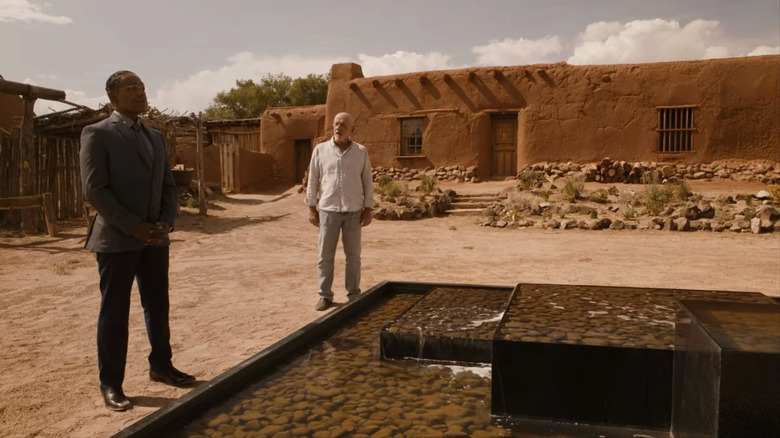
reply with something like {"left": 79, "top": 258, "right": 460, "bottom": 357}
{"left": 358, "top": 50, "right": 459, "bottom": 77}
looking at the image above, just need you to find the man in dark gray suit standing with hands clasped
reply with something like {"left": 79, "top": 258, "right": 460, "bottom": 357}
{"left": 80, "top": 71, "right": 195, "bottom": 411}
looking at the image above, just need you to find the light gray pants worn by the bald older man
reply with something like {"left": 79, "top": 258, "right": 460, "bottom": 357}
{"left": 317, "top": 210, "right": 362, "bottom": 301}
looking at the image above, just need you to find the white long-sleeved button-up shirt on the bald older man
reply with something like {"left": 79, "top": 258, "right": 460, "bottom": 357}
{"left": 306, "top": 139, "right": 374, "bottom": 213}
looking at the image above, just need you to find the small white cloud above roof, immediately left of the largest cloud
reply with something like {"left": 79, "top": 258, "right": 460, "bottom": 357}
{"left": 471, "top": 36, "right": 562, "bottom": 65}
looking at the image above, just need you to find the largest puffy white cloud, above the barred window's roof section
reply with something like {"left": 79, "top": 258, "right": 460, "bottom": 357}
{"left": 568, "top": 18, "right": 730, "bottom": 64}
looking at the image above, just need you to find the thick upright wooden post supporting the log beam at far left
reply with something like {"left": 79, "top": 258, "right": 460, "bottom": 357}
{"left": 19, "top": 97, "right": 40, "bottom": 234}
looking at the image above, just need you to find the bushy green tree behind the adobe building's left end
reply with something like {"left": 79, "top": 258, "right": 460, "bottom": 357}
{"left": 205, "top": 73, "right": 330, "bottom": 119}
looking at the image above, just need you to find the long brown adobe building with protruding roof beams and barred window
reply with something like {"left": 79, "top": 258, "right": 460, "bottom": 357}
{"left": 261, "top": 55, "right": 780, "bottom": 184}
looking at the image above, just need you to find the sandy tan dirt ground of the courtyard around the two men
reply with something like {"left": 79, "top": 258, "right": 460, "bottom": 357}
{"left": 0, "top": 182, "right": 780, "bottom": 438}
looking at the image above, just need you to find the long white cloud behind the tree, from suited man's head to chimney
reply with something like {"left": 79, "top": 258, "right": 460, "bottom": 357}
{"left": 149, "top": 52, "right": 349, "bottom": 113}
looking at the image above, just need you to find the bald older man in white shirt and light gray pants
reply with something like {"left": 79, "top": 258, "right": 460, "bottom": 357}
{"left": 306, "top": 113, "right": 374, "bottom": 311}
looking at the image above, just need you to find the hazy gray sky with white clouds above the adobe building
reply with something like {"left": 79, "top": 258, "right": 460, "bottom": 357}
{"left": 0, "top": 0, "right": 780, "bottom": 114}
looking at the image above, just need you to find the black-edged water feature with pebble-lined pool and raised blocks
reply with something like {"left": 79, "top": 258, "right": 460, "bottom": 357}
{"left": 115, "top": 283, "right": 780, "bottom": 438}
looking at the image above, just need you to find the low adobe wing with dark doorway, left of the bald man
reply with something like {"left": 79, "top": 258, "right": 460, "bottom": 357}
{"left": 260, "top": 105, "right": 329, "bottom": 185}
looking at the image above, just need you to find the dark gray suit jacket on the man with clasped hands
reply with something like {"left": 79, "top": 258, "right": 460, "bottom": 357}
{"left": 79, "top": 112, "right": 178, "bottom": 253}
